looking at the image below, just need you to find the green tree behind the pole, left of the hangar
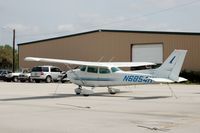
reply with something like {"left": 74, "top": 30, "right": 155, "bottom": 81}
{"left": 0, "top": 45, "right": 18, "bottom": 69}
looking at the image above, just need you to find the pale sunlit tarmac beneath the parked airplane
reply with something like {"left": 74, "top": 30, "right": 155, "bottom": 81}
{"left": 0, "top": 82, "right": 200, "bottom": 133}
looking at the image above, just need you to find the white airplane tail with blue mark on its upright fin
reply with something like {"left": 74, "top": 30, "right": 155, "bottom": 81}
{"left": 155, "top": 50, "right": 187, "bottom": 82}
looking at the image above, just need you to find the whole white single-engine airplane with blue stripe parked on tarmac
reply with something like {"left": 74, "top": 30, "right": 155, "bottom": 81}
{"left": 25, "top": 50, "right": 187, "bottom": 96}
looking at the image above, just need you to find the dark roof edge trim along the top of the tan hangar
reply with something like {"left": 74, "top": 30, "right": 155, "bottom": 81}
{"left": 18, "top": 29, "right": 200, "bottom": 45}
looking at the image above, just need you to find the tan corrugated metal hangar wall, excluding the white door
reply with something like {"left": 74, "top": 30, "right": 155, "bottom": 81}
{"left": 19, "top": 32, "right": 200, "bottom": 71}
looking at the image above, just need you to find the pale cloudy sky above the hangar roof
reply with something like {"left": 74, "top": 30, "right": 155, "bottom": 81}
{"left": 0, "top": 0, "right": 200, "bottom": 45}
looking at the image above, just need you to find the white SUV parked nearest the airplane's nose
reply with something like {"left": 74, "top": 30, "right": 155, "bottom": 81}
{"left": 31, "top": 66, "right": 62, "bottom": 83}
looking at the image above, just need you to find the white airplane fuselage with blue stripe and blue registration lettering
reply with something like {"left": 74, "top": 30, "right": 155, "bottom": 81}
{"left": 67, "top": 69, "right": 153, "bottom": 87}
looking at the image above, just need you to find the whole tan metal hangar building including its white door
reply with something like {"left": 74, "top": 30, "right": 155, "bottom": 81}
{"left": 18, "top": 29, "right": 200, "bottom": 71}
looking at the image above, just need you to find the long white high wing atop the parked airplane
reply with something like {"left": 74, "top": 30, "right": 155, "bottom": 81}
{"left": 25, "top": 57, "right": 155, "bottom": 67}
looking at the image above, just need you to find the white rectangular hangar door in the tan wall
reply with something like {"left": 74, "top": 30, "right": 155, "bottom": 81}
{"left": 132, "top": 44, "right": 163, "bottom": 64}
